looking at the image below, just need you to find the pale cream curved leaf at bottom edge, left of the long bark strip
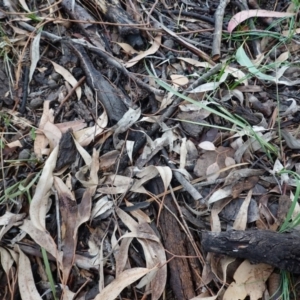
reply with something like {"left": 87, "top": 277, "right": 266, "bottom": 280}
{"left": 95, "top": 268, "right": 156, "bottom": 300}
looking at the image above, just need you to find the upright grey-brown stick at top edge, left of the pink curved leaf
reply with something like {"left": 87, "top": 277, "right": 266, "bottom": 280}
{"left": 212, "top": 0, "right": 230, "bottom": 61}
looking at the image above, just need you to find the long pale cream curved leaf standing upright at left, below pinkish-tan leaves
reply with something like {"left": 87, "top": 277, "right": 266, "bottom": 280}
{"left": 29, "top": 146, "right": 58, "bottom": 231}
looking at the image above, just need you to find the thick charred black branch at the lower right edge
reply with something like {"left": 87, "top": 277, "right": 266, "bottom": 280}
{"left": 202, "top": 230, "right": 300, "bottom": 273}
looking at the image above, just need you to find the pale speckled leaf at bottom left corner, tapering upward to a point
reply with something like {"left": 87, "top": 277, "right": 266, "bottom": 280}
{"left": 18, "top": 248, "right": 42, "bottom": 300}
